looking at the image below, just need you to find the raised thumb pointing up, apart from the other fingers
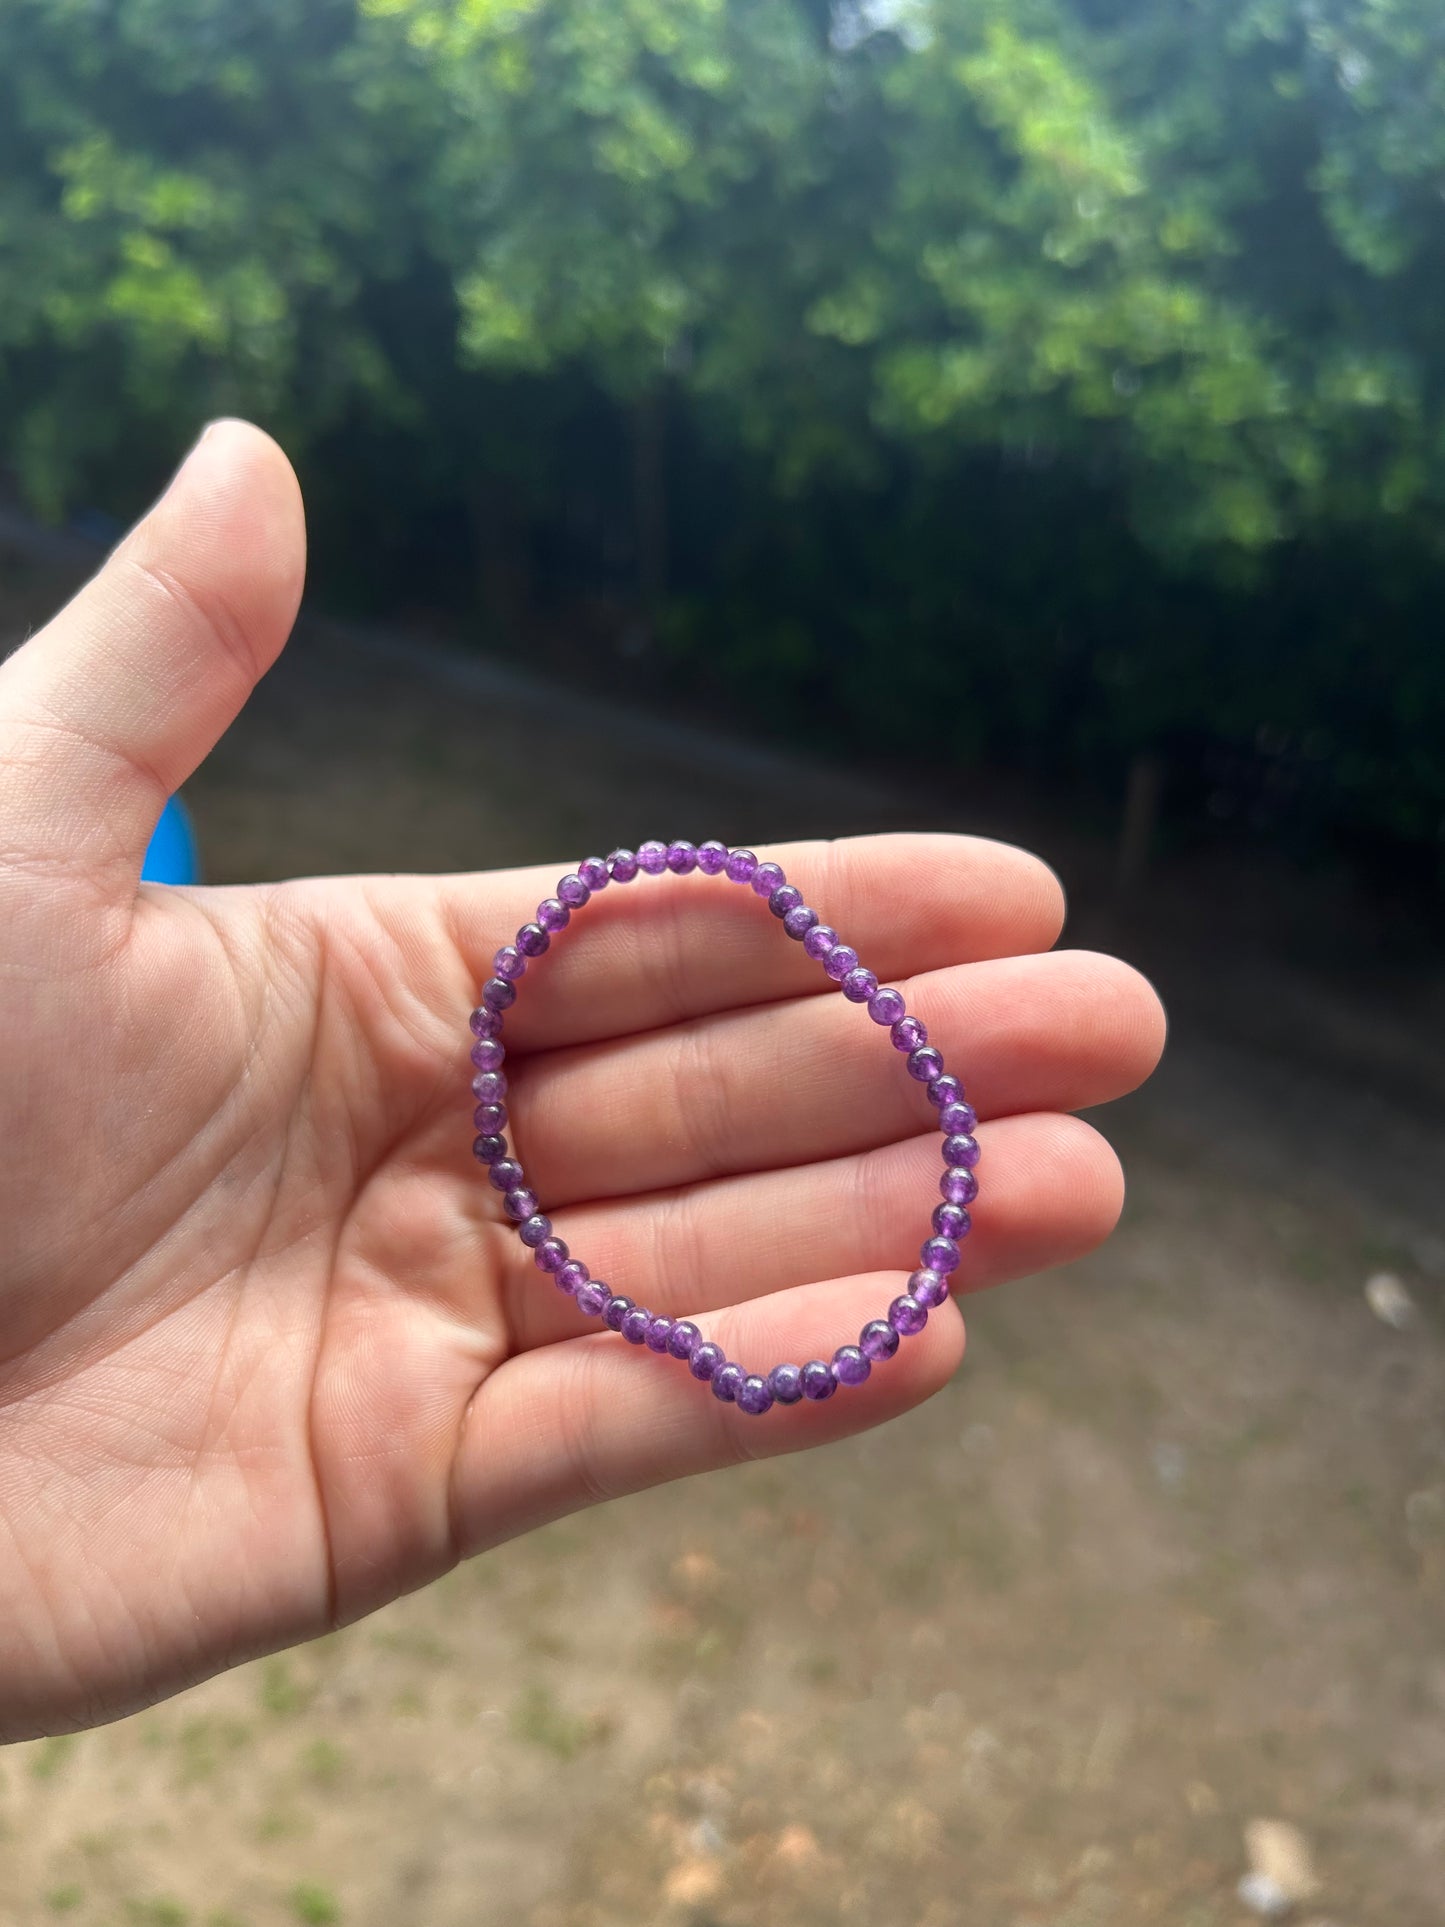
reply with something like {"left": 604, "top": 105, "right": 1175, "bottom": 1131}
{"left": 0, "top": 422, "right": 304, "bottom": 890}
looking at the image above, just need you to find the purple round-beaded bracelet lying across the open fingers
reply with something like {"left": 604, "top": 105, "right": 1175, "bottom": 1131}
{"left": 472, "top": 842, "right": 979, "bottom": 1418}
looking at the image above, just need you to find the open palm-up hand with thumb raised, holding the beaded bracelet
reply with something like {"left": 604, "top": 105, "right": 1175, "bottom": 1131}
{"left": 0, "top": 422, "right": 1162, "bottom": 1738}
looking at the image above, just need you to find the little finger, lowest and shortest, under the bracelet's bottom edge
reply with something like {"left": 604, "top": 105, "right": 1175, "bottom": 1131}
{"left": 451, "top": 1276, "right": 963, "bottom": 1553}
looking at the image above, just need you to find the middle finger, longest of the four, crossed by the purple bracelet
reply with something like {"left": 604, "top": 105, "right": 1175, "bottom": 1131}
{"left": 507, "top": 950, "right": 1164, "bottom": 1206}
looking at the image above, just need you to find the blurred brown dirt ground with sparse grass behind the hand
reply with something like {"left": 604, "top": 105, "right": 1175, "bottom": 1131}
{"left": 0, "top": 543, "right": 1445, "bottom": 1927}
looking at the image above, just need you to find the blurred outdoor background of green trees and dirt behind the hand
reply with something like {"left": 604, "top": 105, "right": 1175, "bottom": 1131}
{"left": 0, "top": 0, "right": 1445, "bottom": 1927}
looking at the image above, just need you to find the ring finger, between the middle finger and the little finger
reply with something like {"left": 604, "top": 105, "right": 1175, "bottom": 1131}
{"left": 503, "top": 1114, "right": 1123, "bottom": 1347}
